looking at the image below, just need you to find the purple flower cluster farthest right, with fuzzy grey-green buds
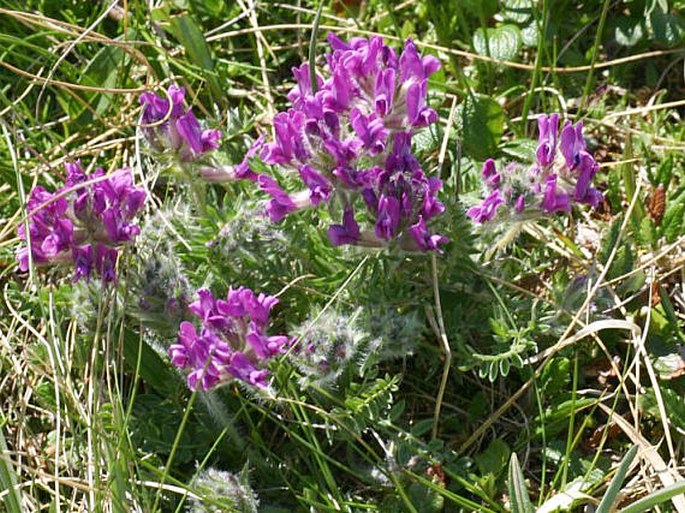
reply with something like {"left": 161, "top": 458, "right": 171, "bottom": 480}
{"left": 467, "top": 114, "right": 604, "bottom": 223}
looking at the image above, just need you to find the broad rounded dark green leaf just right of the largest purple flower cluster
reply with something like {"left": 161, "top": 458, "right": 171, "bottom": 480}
{"left": 456, "top": 96, "right": 504, "bottom": 160}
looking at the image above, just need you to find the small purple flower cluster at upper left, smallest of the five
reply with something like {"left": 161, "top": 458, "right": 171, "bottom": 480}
{"left": 140, "top": 85, "right": 221, "bottom": 162}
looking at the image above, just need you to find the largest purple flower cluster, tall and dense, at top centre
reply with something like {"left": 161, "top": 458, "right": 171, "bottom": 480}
{"left": 243, "top": 34, "right": 447, "bottom": 251}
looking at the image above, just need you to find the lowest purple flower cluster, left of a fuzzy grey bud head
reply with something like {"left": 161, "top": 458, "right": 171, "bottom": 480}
{"left": 169, "top": 287, "right": 293, "bottom": 390}
